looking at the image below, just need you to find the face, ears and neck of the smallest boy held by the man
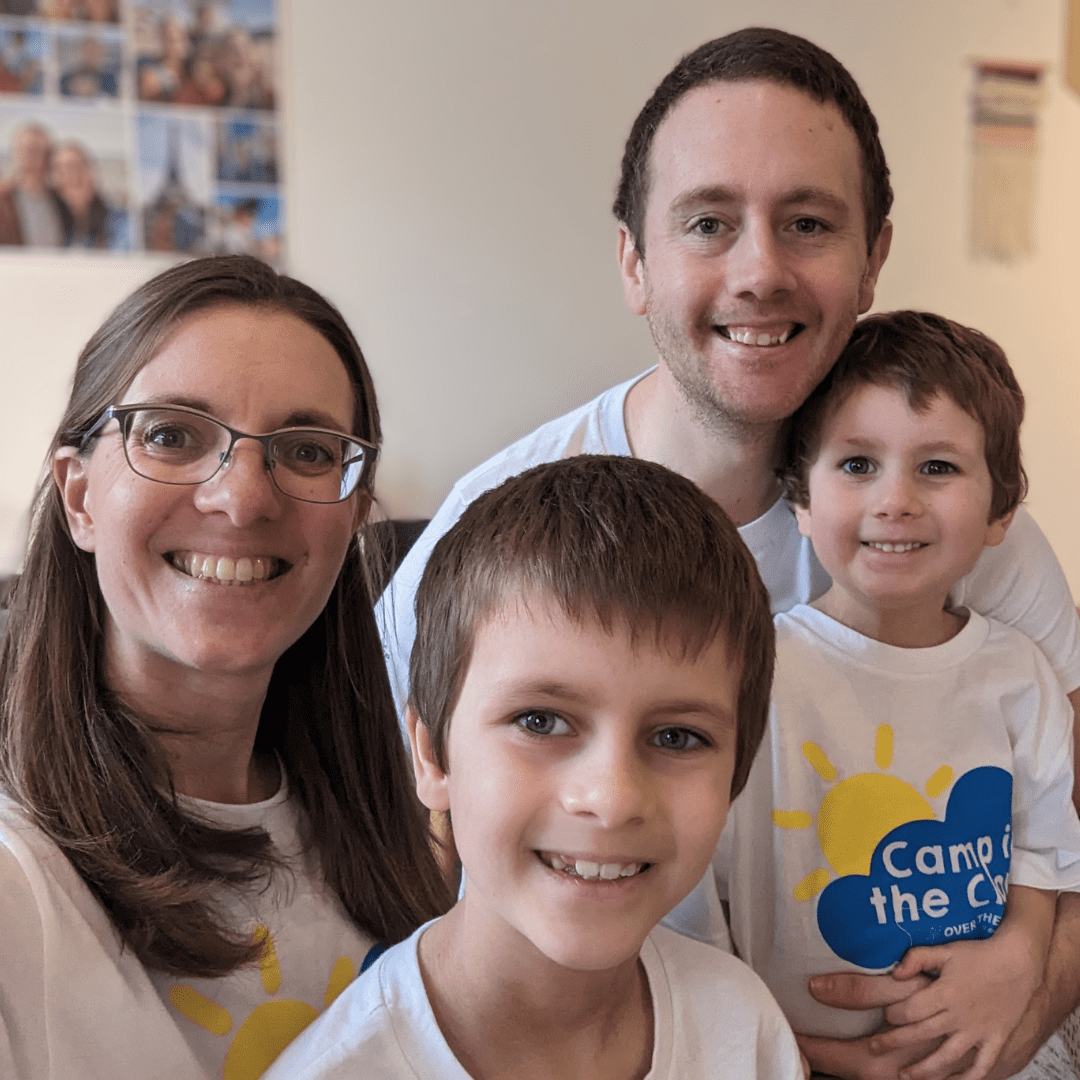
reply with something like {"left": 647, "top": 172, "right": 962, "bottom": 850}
{"left": 795, "top": 386, "right": 1012, "bottom": 647}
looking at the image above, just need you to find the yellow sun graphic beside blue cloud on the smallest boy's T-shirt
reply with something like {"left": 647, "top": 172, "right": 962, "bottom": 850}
{"left": 772, "top": 724, "right": 953, "bottom": 900}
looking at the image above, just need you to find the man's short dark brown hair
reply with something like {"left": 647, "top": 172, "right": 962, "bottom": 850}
{"left": 612, "top": 26, "right": 892, "bottom": 256}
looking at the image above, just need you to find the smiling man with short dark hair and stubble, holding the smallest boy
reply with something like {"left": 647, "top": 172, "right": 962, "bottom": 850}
{"left": 379, "top": 29, "right": 1080, "bottom": 1080}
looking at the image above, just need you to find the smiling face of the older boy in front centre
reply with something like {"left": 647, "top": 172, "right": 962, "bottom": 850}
{"left": 408, "top": 597, "right": 739, "bottom": 971}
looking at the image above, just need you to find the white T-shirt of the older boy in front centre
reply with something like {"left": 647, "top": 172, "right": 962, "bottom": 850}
{"left": 259, "top": 923, "right": 802, "bottom": 1080}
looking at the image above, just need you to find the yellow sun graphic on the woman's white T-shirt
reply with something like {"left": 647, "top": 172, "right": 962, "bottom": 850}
{"left": 168, "top": 926, "right": 356, "bottom": 1080}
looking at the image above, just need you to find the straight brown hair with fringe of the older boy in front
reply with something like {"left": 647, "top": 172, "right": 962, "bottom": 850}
{"left": 409, "top": 455, "right": 773, "bottom": 798}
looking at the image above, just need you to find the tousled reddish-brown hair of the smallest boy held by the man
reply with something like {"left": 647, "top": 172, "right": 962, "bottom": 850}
{"left": 778, "top": 311, "right": 1027, "bottom": 521}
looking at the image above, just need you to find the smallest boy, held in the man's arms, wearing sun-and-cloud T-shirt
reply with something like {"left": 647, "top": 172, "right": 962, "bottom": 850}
{"left": 717, "top": 311, "right": 1080, "bottom": 1077}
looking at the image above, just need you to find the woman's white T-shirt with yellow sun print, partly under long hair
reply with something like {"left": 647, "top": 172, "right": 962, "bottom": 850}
{"left": 0, "top": 783, "right": 372, "bottom": 1080}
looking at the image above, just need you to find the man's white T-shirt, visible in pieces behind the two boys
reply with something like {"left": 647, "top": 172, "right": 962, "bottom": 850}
{"left": 376, "top": 372, "right": 1080, "bottom": 713}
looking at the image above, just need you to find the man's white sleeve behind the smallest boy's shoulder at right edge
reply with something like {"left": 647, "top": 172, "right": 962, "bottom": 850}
{"left": 951, "top": 507, "right": 1080, "bottom": 693}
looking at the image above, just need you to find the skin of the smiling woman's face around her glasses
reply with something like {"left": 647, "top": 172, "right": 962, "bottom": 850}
{"left": 61, "top": 307, "right": 357, "bottom": 682}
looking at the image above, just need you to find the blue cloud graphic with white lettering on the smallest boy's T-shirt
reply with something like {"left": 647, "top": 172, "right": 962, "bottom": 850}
{"left": 818, "top": 766, "right": 1012, "bottom": 969}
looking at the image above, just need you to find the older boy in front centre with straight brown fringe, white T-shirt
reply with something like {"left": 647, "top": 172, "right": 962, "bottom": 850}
{"left": 267, "top": 457, "right": 802, "bottom": 1080}
